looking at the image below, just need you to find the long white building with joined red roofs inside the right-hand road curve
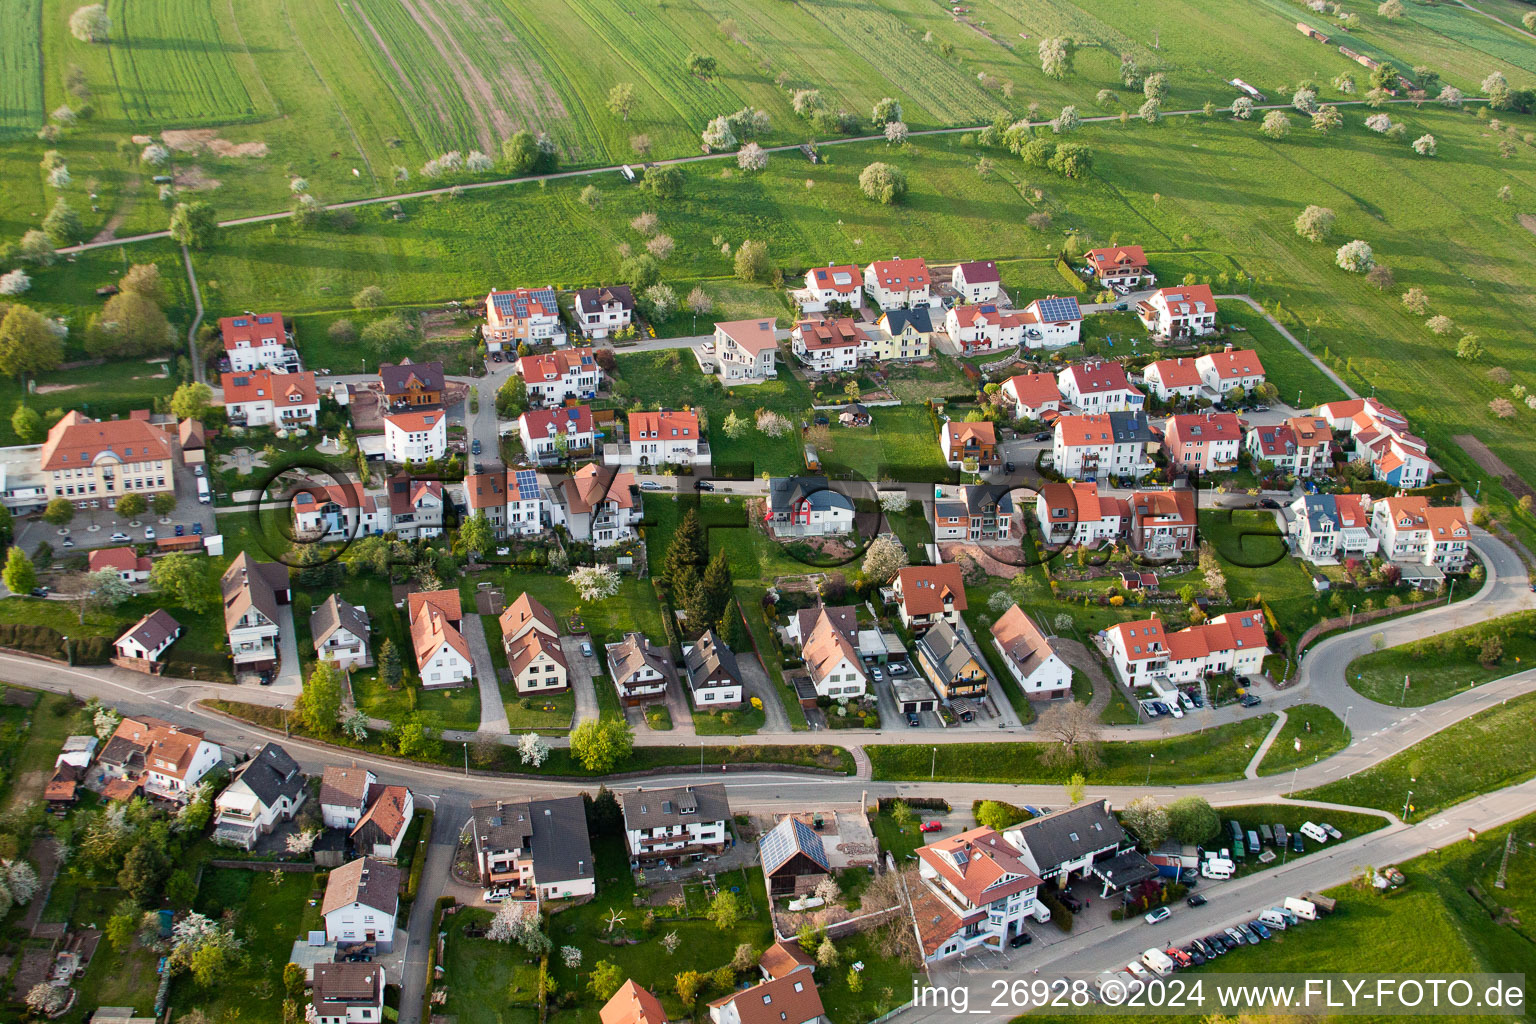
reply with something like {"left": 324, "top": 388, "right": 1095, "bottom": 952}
{"left": 1107, "top": 611, "right": 1269, "bottom": 686}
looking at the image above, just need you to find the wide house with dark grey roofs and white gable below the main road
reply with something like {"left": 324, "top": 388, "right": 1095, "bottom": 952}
{"left": 470, "top": 797, "right": 598, "bottom": 900}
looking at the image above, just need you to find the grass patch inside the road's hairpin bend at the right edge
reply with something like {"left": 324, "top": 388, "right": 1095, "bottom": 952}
{"left": 1347, "top": 611, "right": 1536, "bottom": 708}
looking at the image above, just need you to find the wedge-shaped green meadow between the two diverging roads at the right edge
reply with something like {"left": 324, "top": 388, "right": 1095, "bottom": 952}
{"left": 1296, "top": 694, "right": 1536, "bottom": 821}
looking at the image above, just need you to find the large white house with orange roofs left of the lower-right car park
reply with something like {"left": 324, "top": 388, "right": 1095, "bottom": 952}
{"left": 912, "top": 826, "right": 1051, "bottom": 963}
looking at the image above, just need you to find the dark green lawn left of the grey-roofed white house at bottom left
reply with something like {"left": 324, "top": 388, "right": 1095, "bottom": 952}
{"left": 170, "top": 867, "right": 324, "bottom": 1019}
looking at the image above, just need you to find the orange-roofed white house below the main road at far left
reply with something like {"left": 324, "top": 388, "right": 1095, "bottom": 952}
{"left": 95, "top": 715, "right": 221, "bottom": 804}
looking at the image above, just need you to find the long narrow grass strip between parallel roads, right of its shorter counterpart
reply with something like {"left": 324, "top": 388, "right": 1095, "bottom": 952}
{"left": 865, "top": 714, "right": 1275, "bottom": 786}
